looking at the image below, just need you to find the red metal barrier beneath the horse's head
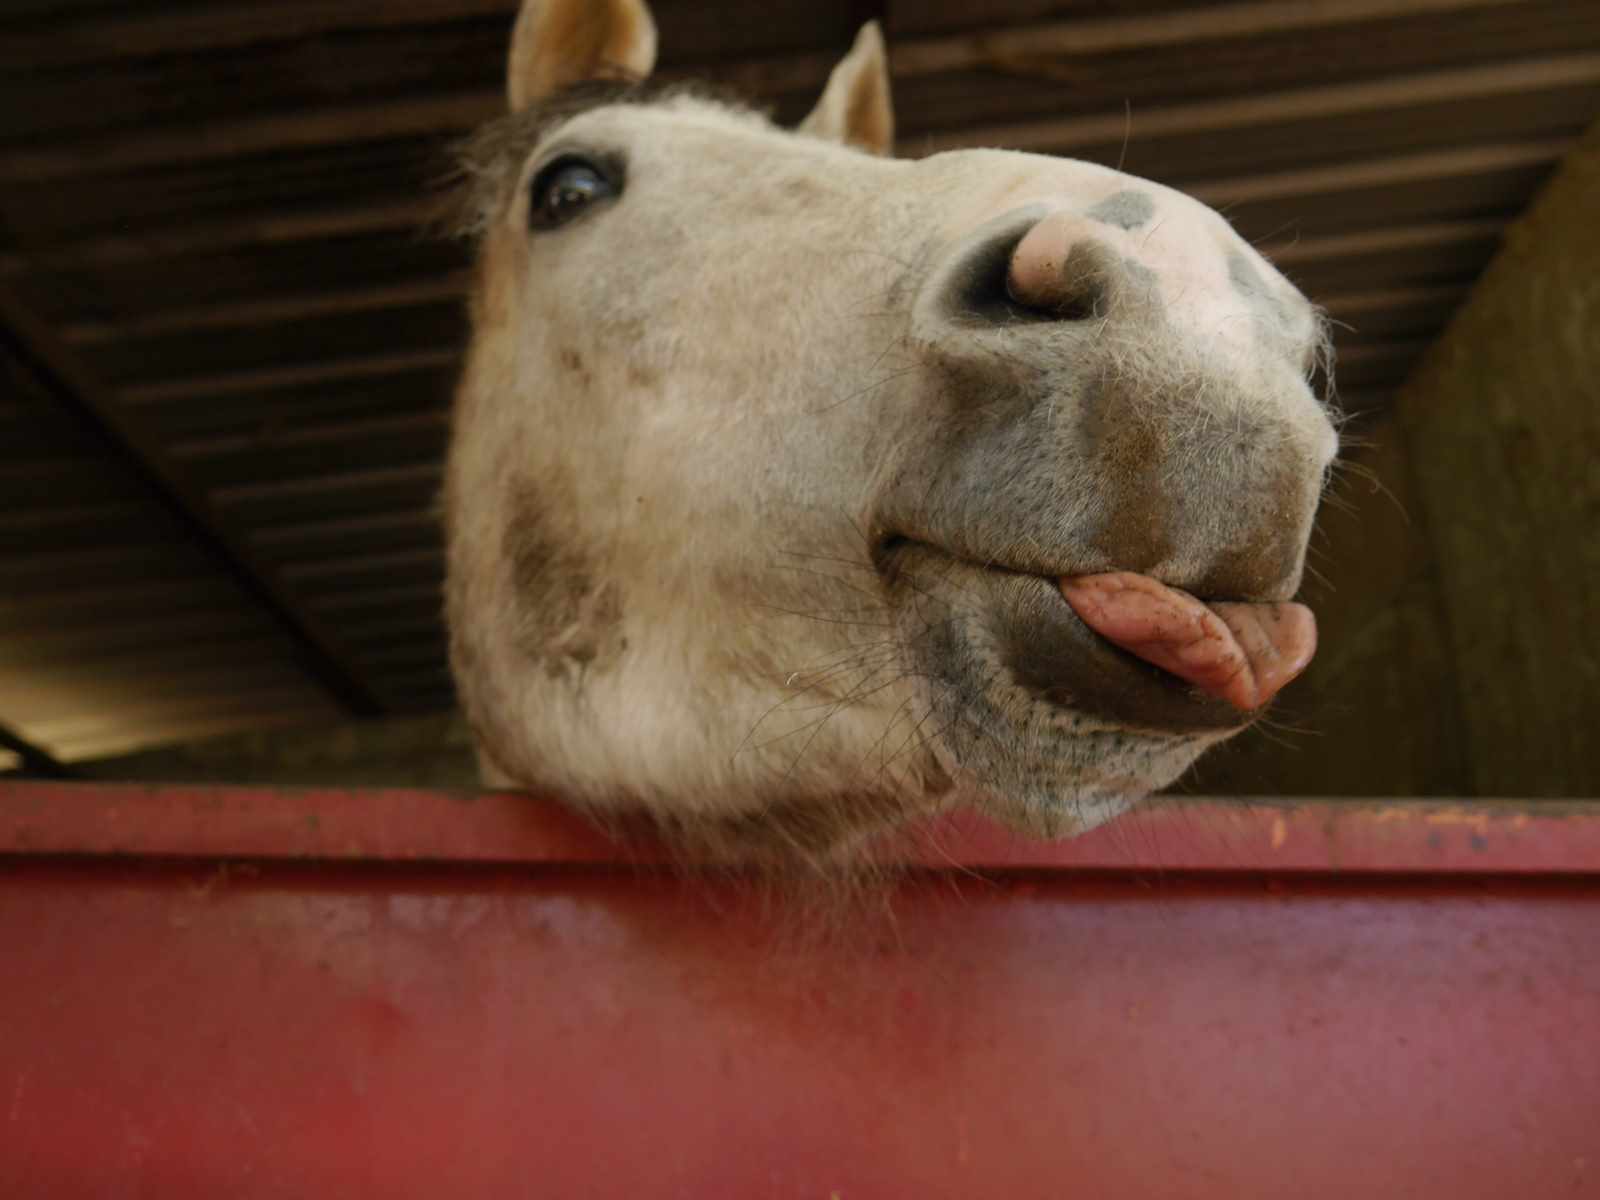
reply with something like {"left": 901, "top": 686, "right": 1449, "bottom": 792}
{"left": 0, "top": 784, "right": 1600, "bottom": 1200}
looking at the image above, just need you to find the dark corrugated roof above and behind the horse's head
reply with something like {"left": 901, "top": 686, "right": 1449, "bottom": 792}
{"left": 0, "top": 0, "right": 1600, "bottom": 768}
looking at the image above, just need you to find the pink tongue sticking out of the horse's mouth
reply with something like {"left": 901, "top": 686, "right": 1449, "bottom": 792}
{"left": 1061, "top": 571, "right": 1317, "bottom": 710}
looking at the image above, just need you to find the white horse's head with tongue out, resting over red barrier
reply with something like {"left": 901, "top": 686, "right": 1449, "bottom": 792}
{"left": 446, "top": 0, "right": 1338, "bottom": 859}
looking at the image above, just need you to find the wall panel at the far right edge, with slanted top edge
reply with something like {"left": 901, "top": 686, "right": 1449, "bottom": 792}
{"left": 1397, "top": 117, "right": 1600, "bottom": 795}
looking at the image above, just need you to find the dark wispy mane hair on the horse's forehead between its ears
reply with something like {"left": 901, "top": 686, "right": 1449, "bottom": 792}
{"left": 445, "top": 80, "right": 752, "bottom": 238}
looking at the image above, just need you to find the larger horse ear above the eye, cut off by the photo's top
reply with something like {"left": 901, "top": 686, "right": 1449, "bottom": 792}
{"left": 506, "top": 0, "right": 656, "bottom": 112}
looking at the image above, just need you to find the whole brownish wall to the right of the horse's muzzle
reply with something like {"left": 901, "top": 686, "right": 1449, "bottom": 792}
{"left": 1190, "top": 126, "right": 1600, "bottom": 797}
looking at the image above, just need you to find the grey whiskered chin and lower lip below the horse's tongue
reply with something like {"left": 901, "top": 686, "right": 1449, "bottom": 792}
{"left": 885, "top": 542, "right": 1228, "bottom": 837}
